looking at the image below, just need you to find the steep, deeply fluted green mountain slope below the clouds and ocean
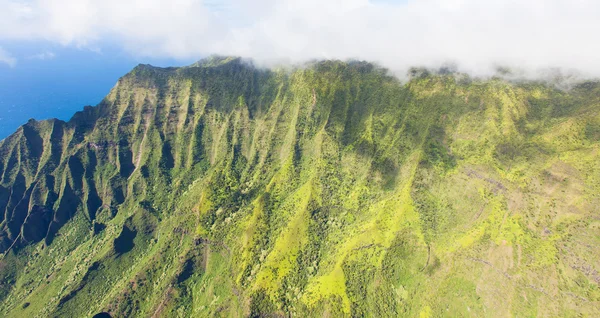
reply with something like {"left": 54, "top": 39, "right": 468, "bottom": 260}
{"left": 0, "top": 58, "right": 600, "bottom": 317}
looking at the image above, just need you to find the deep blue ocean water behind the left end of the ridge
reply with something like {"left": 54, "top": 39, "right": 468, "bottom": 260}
{"left": 0, "top": 45, "right": 192, "bottom": 139}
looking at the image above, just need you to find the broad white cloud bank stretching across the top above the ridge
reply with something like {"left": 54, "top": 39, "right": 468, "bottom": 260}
{"left": 0, "top": 0, "right": 600, "bottom": 76}
